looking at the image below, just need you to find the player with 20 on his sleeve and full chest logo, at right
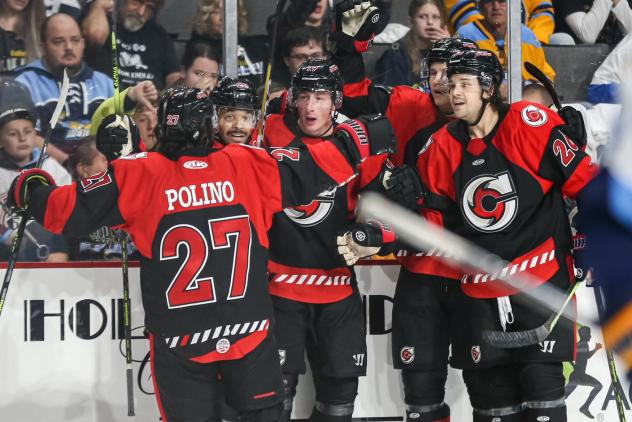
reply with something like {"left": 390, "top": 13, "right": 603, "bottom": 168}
{"left": 418, "top": 50, "right": 596, "bottom": 422}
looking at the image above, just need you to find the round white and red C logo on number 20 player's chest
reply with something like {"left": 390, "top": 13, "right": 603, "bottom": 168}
{"left": 461, "top": 172, "right": 518, "bottom": 233}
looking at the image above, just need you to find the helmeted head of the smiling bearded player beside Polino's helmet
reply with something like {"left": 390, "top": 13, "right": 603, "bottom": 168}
{"left": 212, "top": 77, "right": 260, "bottom": 145}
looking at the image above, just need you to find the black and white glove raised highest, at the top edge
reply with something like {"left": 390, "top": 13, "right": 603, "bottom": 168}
{"left": 336, "top": 0, "right": 381, "bottom": 53}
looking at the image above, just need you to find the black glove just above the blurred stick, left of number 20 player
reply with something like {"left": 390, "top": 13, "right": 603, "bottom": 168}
{"left": 385, "top": 165, "right": 426, "bottom": 211}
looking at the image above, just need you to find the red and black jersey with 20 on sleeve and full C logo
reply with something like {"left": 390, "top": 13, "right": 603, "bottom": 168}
{"left": 418, "top": 102, "right": 597, "bottom": 297}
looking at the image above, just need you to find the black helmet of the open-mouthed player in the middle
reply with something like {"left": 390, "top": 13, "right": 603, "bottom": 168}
{"left": 288, "top": 59, "right": 344, "bottom": 109}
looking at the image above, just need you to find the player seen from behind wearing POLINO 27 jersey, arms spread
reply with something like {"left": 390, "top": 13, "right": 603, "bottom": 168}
{"left": 9, "top": 89, "right": 392, "bottom": 422}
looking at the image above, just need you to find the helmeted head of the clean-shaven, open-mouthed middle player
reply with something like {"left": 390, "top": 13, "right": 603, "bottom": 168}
{"left": 288, "top": 59, "right": 343, "bottom": 137}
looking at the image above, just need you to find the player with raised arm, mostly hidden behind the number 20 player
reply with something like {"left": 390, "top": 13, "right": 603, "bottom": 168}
{"left": 337, "top": 5, "right": 478, "bottom": 422}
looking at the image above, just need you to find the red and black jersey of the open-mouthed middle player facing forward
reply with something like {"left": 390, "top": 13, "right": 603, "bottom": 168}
{"left": 264, "top": 112, "right": 386, "bottom": 303}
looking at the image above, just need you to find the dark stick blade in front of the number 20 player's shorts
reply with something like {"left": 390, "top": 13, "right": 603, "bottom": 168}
{"left": 482, "top": 283, "right": 581, "bottom": 349}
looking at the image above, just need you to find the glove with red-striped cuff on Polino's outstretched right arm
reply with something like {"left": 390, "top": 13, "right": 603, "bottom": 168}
{"left": 334, "top": 114, "right": 397, "bottom": 166}
